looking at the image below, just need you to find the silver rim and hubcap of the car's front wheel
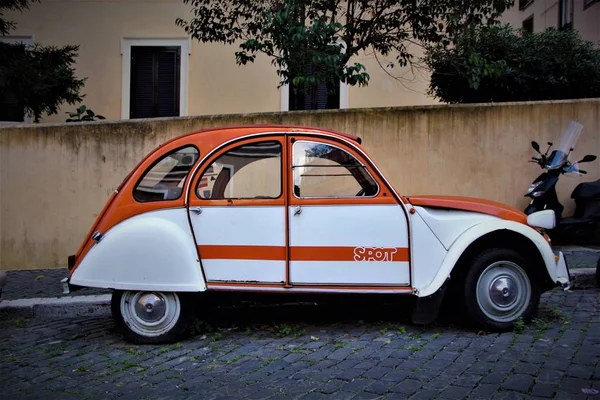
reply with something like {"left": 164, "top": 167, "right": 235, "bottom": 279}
{"left": 476, "top": 261, "right": 531, "bottom": 322}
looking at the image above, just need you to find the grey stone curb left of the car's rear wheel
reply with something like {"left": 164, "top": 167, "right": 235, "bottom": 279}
{"left": 0, "top": 294, "right": 111, "bottom": 318}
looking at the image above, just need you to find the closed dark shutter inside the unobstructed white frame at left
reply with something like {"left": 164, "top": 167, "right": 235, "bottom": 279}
{"left": 130, "top": 46, "right": 181, "bottom": 118}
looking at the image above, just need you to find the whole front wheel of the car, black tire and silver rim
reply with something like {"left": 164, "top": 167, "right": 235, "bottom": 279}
{"left": 463, "top": 248, "right": 541, "bottom": 332}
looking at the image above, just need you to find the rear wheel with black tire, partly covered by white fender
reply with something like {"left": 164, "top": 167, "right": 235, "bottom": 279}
{"left": 111, "top": 290, "right": 194, "bottom": 344}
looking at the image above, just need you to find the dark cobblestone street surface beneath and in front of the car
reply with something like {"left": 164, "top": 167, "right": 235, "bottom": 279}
{"left": 0, "top": 289, "right": 600, "bottom": 400}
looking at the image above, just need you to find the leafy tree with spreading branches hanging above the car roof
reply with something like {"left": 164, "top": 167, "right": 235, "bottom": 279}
{"left": 176, "top": 0, "right": 514, "bottom": 106}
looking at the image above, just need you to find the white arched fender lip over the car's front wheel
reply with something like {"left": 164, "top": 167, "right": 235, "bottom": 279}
{"left": 415, "top": 220, "right": 569, "bottom": 297}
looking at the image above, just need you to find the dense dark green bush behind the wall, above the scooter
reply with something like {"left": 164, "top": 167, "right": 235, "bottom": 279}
{"left": 425, "top": 25, "right": 600, "bottom": 103}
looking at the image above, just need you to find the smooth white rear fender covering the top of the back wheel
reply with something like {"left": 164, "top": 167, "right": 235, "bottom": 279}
{"left": 69, "top": 208, "right": 206, "bottom": 292}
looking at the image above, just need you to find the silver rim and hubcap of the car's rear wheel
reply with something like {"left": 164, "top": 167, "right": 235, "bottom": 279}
{"left": 121, "top": 292, "right": 181, "bottom": 337}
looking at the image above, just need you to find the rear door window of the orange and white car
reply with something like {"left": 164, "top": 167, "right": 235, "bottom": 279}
{"left": 196, "top": 140, "right": 282, "bottom": 200}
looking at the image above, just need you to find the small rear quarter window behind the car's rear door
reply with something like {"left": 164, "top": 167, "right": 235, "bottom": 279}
{"left": 133, "top": 146, "right": 198, "bottom": 202}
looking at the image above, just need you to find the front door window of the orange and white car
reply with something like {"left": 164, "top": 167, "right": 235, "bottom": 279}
{"left": 292, "top": 141, "right": 379, "bottom": 198}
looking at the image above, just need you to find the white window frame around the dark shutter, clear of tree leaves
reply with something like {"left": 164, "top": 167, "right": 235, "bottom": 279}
{"left": 121, "top": 37, "right": 192, "bottom": 119}
